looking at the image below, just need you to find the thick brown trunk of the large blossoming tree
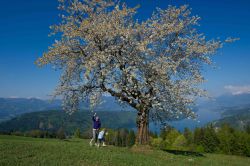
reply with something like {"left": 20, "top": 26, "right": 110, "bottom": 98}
{"left": 137, "top": 110, "right": 149, "bottom": 145}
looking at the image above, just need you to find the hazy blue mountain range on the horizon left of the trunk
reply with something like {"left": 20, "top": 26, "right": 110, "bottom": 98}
{"left": 0, "top": 97, "right": 133, "bottom": 122}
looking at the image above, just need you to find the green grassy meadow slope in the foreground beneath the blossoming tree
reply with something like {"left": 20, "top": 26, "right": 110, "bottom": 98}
{"left": 0, "top": 135, "right": 250, "bottom": 166}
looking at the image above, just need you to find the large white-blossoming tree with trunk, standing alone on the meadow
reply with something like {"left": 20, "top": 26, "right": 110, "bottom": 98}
{"left": 37, "top": 0, "right": 233, "bottom": 144}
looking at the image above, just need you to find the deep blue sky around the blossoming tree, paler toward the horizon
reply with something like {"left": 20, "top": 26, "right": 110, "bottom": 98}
{"left": 0, "top": 0, "right": 250, "bottom": 98}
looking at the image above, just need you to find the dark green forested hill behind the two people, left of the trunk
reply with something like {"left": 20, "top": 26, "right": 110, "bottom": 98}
{"left": 0, "top": 110, "right": 136, "bottom": 134}
